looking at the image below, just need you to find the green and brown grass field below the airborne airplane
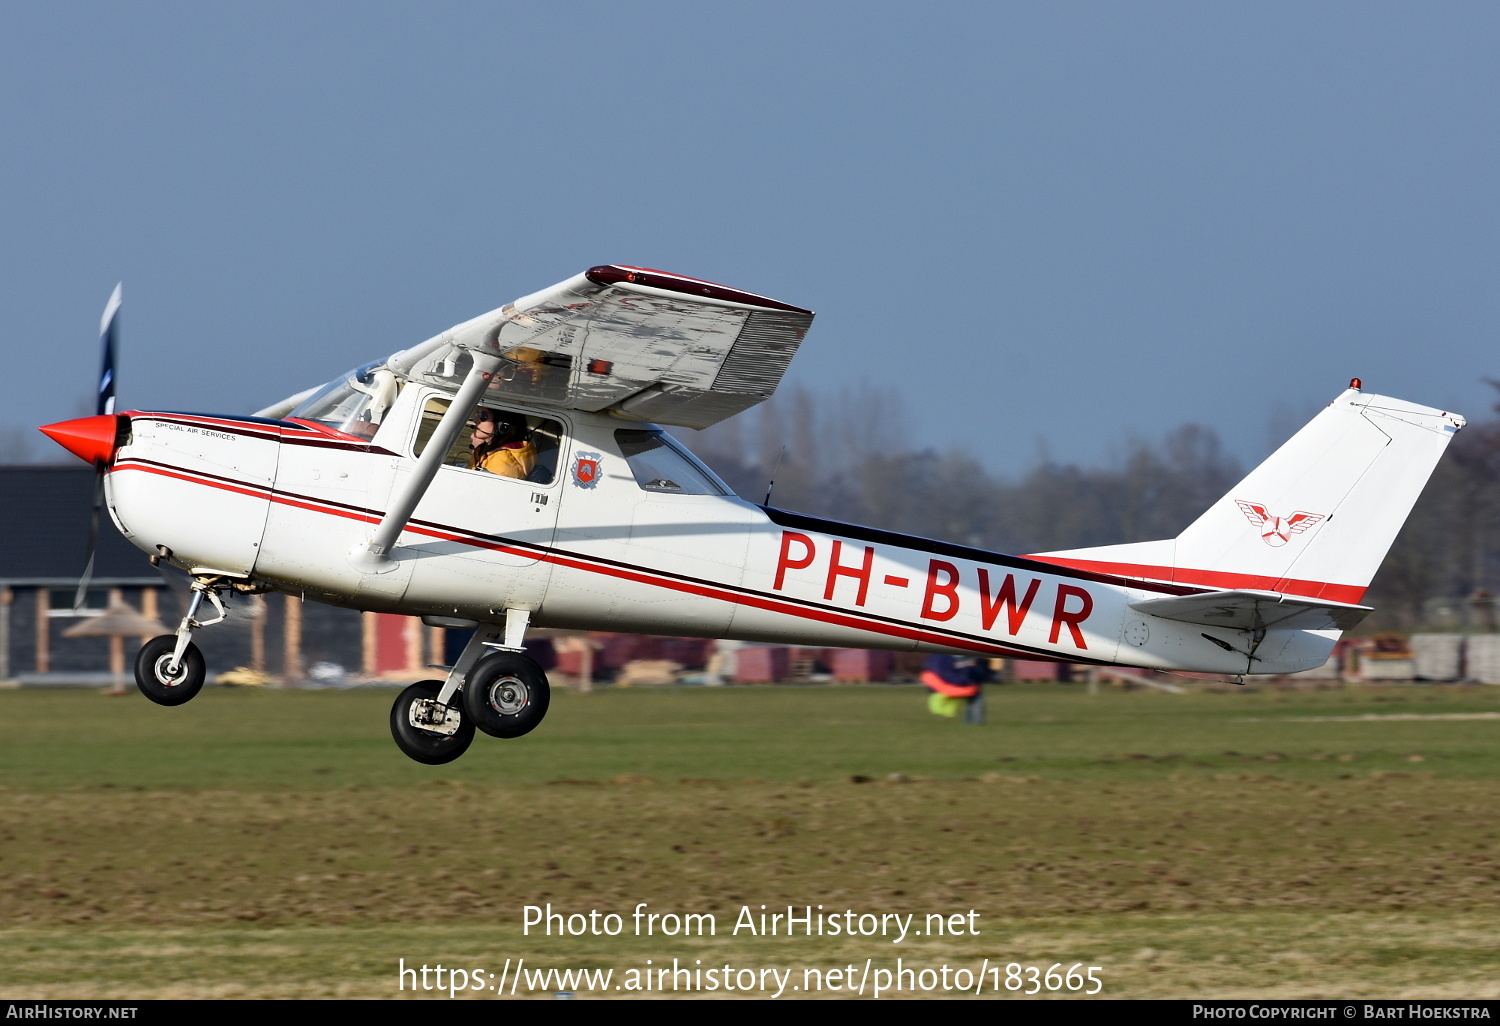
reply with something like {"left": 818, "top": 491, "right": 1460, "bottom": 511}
{"left": 0, "top": 686, "right": 1500, "bottom": 999}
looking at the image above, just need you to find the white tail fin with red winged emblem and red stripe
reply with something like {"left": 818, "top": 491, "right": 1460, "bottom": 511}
{"left": 1035, "top": 386, "right": 1466, "bottom": 603}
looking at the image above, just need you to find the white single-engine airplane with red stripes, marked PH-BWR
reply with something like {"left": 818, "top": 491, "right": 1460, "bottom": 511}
{"left": 42, "top": 266, "right": 1464, "bottom": 764}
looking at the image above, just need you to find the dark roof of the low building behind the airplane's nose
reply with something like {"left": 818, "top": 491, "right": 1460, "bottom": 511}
{"left": 0, "top": 467, "right": 161, "bottom": 584}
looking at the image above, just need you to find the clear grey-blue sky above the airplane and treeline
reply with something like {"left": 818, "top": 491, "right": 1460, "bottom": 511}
{"left": 0, "top": 3, "right": 1500, "bottom": 471}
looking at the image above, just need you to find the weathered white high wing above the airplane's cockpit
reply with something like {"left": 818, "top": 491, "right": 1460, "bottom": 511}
{"left": 387, "top": 264, "right": 813, "bottom": 428}
